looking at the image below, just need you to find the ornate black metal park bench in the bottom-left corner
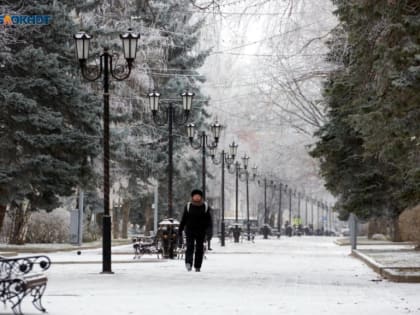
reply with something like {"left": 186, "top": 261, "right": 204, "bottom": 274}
{"left": 0, "top": 256, "right": 51, "bottom": 315}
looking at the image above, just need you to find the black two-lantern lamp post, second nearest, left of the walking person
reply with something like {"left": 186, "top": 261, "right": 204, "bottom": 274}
{"left": 149, "top": 91, "right": 194, "bottom": 218}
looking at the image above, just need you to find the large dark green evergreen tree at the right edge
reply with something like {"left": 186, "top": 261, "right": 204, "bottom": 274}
{"left": 312, "top": 0, "right": 420, "bottom": 237}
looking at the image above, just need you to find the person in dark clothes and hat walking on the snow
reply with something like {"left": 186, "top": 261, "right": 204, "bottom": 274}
{"left": 179, "top": 189, "right": 212, "bottom": 272}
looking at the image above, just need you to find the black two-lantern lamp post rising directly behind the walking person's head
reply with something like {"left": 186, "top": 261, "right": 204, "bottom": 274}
{"left": 187, "top": 121, "right": 222, "bottom": 198}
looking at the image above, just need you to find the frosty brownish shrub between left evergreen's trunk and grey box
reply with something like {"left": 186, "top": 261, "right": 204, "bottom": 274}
{"left": 26, "top": 209, "right": 70, "bottom": 243}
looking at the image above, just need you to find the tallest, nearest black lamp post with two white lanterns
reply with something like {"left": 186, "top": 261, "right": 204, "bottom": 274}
{"left": 73, "top": 29, "right": 140, "bottom": 273}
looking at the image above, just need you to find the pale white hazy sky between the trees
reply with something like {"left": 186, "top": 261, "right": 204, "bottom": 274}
{"left": 202, "top": 0, "right": 336, "bottom": 204}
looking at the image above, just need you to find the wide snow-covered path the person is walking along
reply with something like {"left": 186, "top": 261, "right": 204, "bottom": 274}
{"left": 5, "top": 237, "right": 420, "bottom": 315}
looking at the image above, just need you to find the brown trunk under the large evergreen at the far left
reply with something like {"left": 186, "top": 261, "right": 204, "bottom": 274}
{"left": 9, "top": 203, "right": 32, "bottom": 245}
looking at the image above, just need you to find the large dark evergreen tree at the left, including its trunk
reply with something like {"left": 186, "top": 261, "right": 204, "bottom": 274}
{"left": 0, "top": 0, "right": 100, "bottom": 243}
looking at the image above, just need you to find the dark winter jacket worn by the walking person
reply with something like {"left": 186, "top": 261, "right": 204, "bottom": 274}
{"left": 179, "top": 203, "right": 213, "bottom": 236}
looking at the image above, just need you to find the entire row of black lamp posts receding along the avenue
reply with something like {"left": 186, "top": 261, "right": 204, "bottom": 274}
{"left": 74, "top": 29, "right": 334, "bottom": 273}
